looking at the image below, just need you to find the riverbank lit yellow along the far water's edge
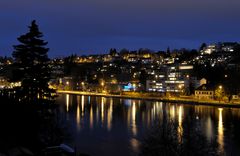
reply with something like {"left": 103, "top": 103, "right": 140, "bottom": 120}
{"left": 57, "top": 90, "right": 240, "bottom": 108}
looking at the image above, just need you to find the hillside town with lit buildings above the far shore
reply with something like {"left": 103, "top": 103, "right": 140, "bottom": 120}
{"left": 0, "top": 42, "right": 240, "bottom": 102}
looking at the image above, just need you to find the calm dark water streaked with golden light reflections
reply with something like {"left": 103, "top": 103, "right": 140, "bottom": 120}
{"left": 57, "top": 94, "right": 240, "bottom": 156}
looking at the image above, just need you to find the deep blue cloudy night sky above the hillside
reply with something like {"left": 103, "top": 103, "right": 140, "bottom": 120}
{"left": 0, "top": 0, "right": 240, "bottom": 57}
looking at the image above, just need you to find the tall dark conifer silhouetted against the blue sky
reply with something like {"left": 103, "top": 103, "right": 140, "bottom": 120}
{"left": 12, "top": 20, "right": 54, "bottom": 101}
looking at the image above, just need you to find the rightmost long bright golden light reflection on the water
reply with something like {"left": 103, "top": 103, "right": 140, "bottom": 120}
{"left": 218, "top": 108, "right": 224, "bottom": 152}
